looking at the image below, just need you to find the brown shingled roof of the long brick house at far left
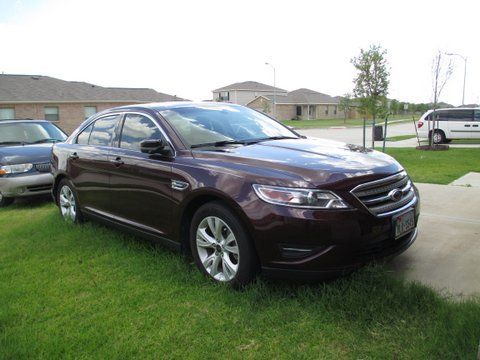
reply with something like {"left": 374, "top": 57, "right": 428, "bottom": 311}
{"left": 0, "top": 74, "right": 183, "bottom": 103}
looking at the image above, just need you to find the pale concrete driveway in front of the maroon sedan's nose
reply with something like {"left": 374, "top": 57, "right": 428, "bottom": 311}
{"left": 389, "top": 184, "right": 480, "bottom": 297}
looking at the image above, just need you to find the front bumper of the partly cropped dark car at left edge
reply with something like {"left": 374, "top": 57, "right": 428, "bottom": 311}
{"left": 0, "top": 173, "right": 53, "bottom": 197}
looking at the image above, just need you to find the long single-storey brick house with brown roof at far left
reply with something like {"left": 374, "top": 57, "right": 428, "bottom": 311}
{"left": 0, "top": 74, "right": 183, "bottom": 133}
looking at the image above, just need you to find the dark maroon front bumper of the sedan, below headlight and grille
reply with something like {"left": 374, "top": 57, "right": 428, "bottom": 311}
{"left": 247, "top": 194, "right": 420, "bottom": 278}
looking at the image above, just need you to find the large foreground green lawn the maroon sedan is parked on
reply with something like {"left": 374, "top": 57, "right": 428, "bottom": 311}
{"left": 0, "top": 201, "right": 480, "bottom": 359}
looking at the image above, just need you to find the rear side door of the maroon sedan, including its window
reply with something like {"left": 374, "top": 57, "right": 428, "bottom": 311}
{"left": 68, "top": 114, "right": 121, "bottom": 211}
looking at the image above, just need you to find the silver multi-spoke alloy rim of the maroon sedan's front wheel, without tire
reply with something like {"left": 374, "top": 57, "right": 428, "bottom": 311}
{"left": 196, "top": 216, "right": 240, "bottom": 281}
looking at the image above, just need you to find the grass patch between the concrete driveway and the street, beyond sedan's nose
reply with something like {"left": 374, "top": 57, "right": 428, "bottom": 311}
{"left": 385, "top": 148, "right": 480, "bottom": 184}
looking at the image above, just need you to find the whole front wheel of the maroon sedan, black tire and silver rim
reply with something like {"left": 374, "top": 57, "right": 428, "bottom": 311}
{"left": 190, "top": 202, "right": 259, "bottom": 288}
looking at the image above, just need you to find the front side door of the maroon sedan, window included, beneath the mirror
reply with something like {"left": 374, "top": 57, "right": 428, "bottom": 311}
{"left": 110, "top": 113, "right": 175, "bottom": 237}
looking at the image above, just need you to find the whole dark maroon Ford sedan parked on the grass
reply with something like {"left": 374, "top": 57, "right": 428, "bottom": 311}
{"left": 52, "top": 102, "right": 419, "bottom": 286}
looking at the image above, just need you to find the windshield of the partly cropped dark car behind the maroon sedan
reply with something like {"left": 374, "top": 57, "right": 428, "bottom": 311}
{"left": 0, "top": 121, "right": 67, "bottom": 146}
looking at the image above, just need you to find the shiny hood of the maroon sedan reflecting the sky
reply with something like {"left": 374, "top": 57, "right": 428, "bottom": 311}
{"left": 194, "top": 138, "right": 403, "bottom": 186}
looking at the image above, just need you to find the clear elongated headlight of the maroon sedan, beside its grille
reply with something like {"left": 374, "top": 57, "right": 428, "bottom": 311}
{"left": 253, "top": 184, "right": 350, "bottom": 209}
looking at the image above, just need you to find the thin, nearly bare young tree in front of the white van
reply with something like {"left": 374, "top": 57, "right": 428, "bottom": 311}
{"left": 428, "top": 51, "right": 453, "bottom": 147}
